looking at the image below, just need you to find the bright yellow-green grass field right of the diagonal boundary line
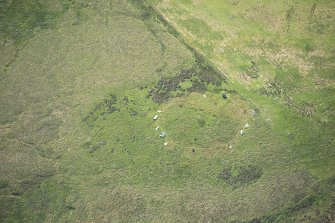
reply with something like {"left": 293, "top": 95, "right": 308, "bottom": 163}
{"left": 153, "top": 0, "right": 334, "bottom": 222}
